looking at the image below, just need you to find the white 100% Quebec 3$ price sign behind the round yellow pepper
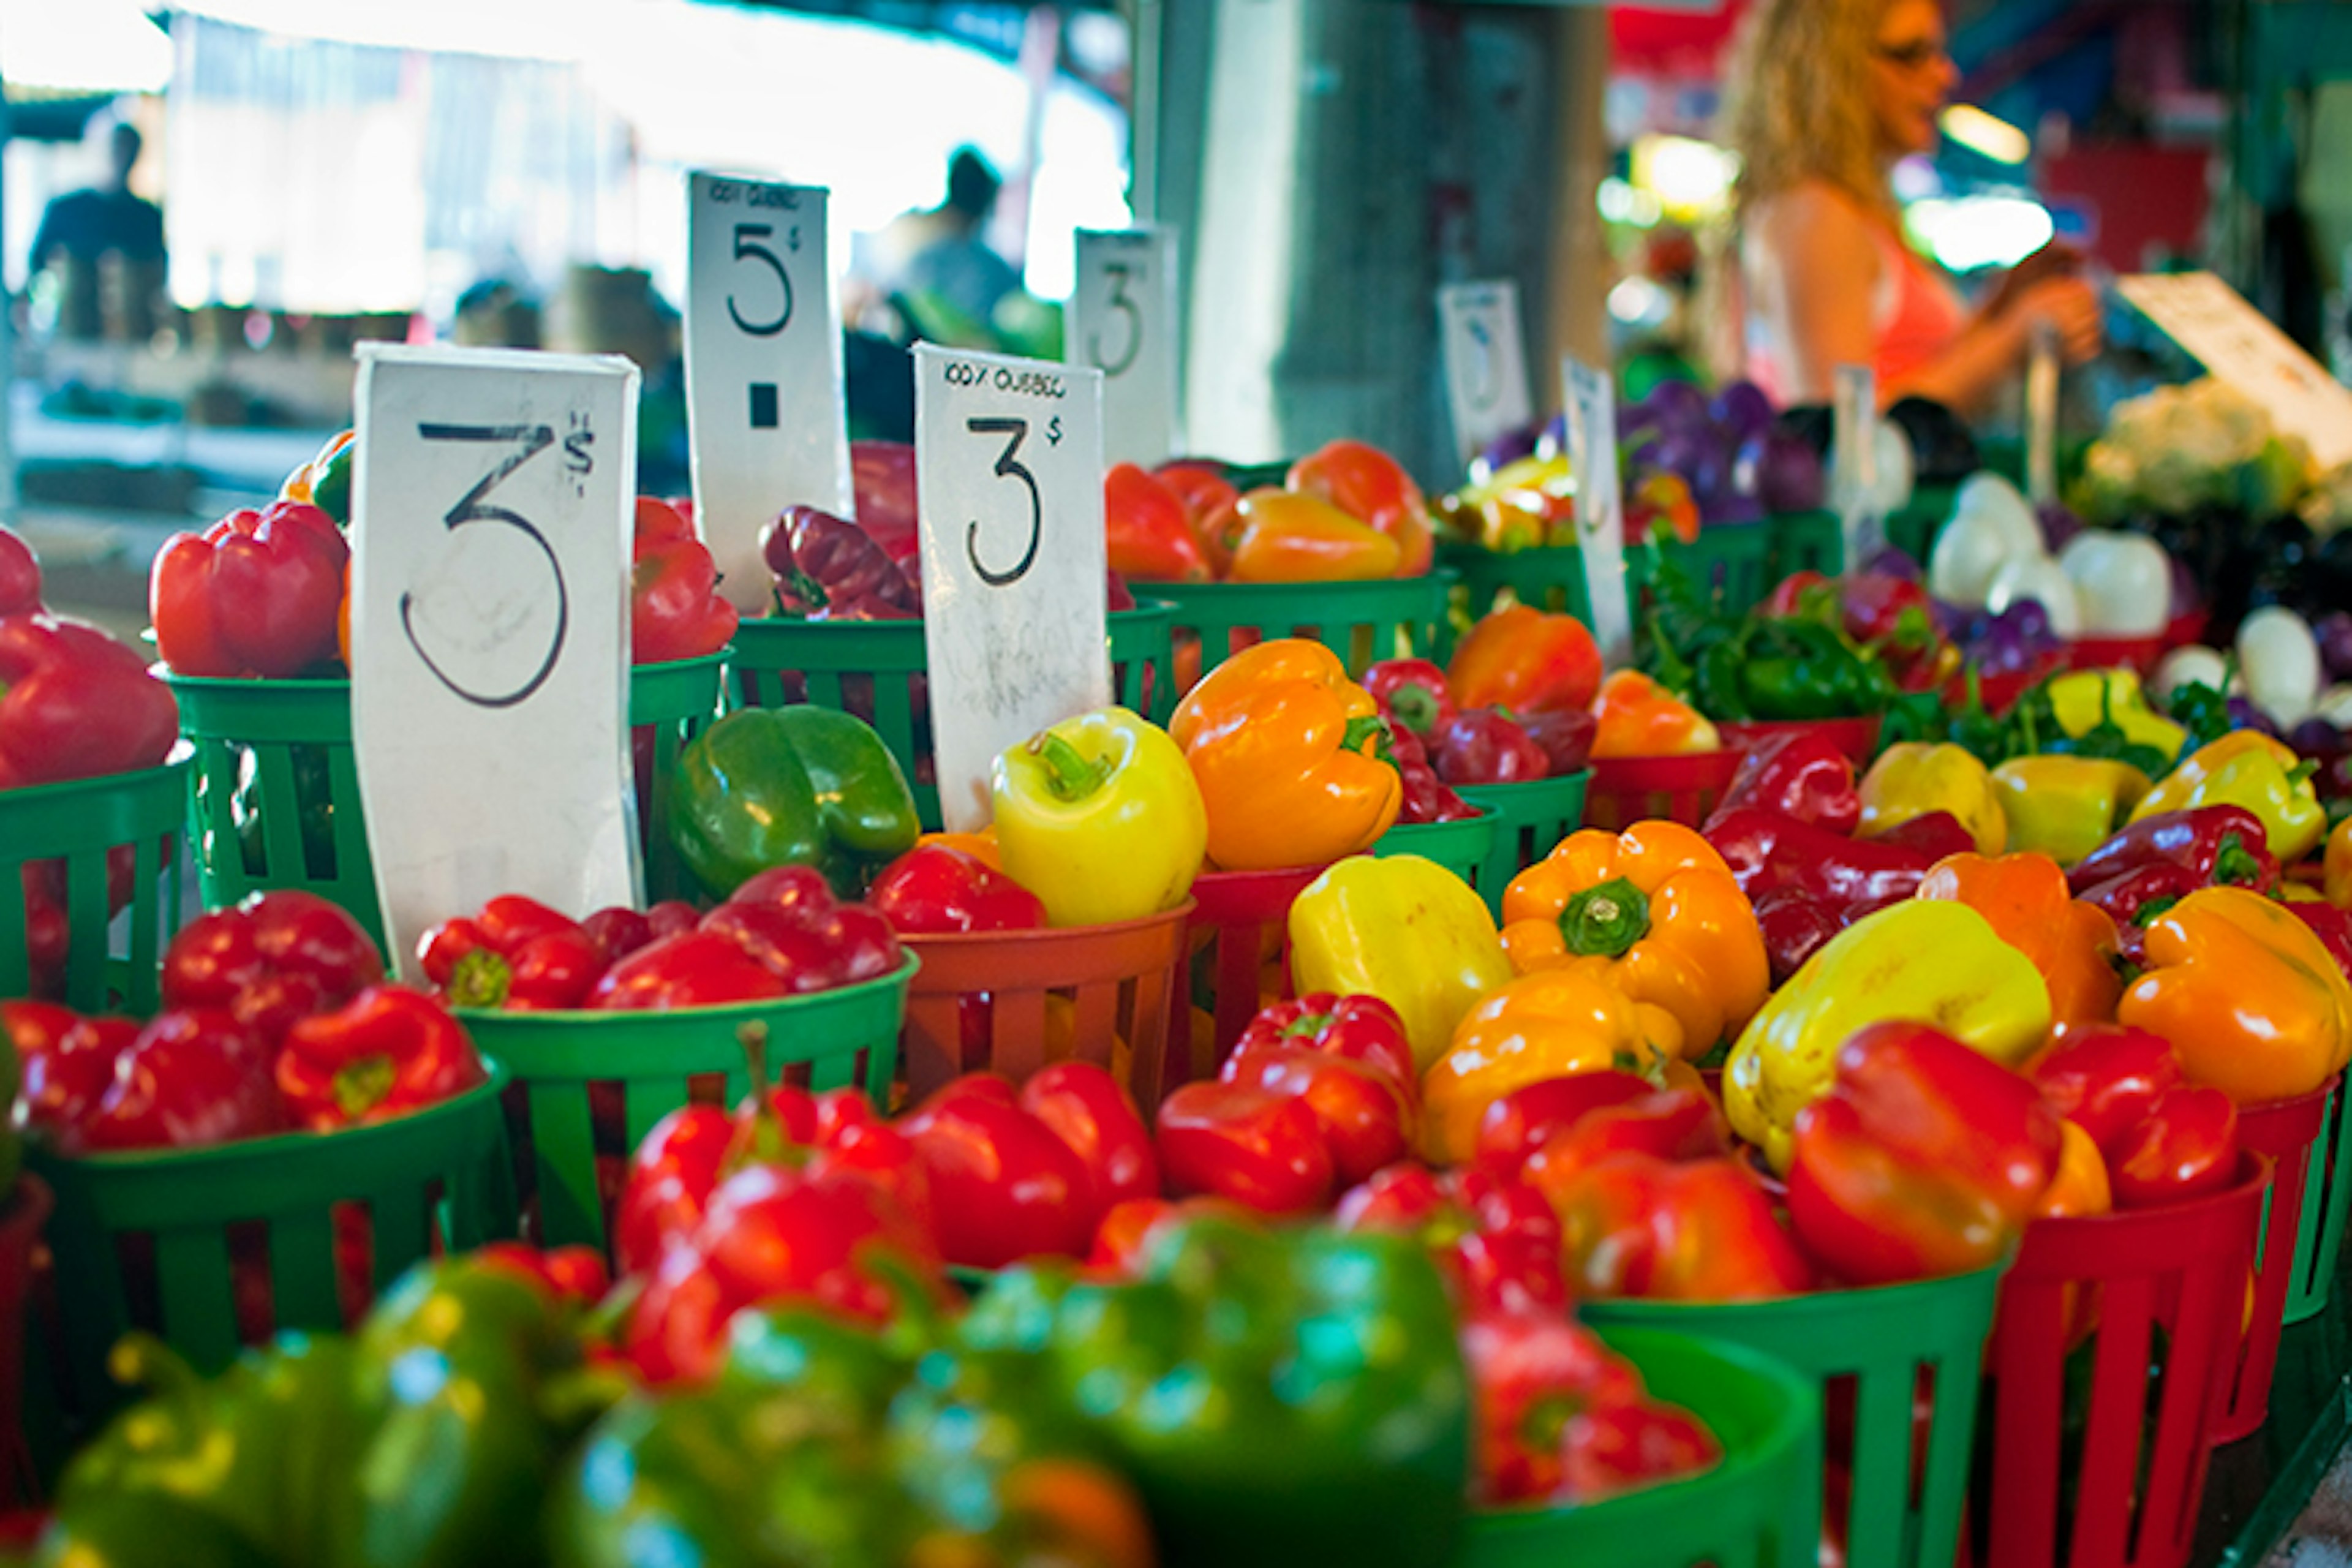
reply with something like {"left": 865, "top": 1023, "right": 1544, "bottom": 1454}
{"left": 915, "top": 343, "right": 1110, "bottom": 832}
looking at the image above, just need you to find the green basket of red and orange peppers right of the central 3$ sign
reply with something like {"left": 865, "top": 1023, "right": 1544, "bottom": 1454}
{"left": 1153, "top": 571, "right": 1453, "bottom": 677}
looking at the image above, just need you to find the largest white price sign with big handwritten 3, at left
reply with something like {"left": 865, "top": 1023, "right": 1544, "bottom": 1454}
{"left": 350, "top": 345, "right": 638, "bottom": 968}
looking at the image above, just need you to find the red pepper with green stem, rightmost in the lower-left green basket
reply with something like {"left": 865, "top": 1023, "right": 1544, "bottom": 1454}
{"left": 277, "top": 985, "right": 489, "bottom": 1133}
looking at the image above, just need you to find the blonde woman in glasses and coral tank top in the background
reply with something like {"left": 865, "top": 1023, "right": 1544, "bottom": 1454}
{"left": 1724, "top": 0, "right": 2100, "bottom": 412}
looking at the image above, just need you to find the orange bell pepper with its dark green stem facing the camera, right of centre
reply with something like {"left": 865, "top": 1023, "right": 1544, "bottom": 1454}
{"left": 1503, "top": 820, "right": 1771, "bottom": 1055}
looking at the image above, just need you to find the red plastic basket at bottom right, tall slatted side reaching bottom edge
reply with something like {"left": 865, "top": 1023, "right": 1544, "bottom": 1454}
{"left": 1971, "top": 1154, "right": 2272, "bottom": 1568}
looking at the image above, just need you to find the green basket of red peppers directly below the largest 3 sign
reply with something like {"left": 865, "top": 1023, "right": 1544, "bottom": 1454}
{"left": 459, "top": 954, "right": 918, "bottom": 1251}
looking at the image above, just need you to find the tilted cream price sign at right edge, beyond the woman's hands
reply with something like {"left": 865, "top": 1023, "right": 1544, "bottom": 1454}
{"left": 2114, "top": 273, "right": 2352, "bottom": 468}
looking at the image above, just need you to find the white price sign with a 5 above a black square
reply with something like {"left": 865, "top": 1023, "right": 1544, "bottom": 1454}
{"left": 687, "top": 174, "right": 854, "bottom": 611}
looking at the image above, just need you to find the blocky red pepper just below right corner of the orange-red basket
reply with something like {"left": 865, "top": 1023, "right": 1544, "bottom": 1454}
{"left": 1157, "top": 1082, "right": 1331, "bottom": 1215}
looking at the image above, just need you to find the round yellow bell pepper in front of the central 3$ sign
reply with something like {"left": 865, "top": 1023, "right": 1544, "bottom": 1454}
{"left": 990, "top": 707, "right": 1213, "bottom": 926}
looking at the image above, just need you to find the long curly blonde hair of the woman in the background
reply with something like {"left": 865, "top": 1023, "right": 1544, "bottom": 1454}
{"left": 1722, "top": 0, "right": 1896, "bottom": 216}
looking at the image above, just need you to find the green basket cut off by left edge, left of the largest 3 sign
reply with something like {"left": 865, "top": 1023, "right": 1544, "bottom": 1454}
{"left": 0, "top": 748, "right": 188, "bottom": 1016}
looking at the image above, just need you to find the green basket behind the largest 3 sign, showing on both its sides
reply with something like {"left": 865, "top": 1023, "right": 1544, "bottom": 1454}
{"left": 165, "top": 654, "right": 725, "bottom": 948}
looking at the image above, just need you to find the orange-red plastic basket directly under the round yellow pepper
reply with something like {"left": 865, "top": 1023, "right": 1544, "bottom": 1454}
{"left": 901, "top": 898, "right": 1193, "bottom": 1117}
